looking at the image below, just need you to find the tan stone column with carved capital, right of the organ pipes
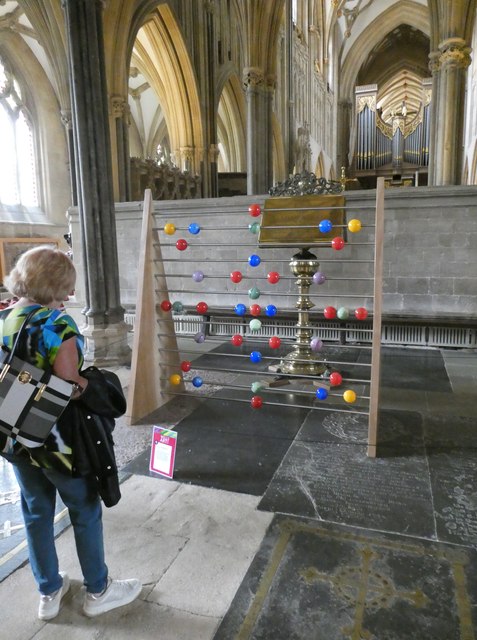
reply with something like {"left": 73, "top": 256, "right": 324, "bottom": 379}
{"left": 429, "top": 37, "right": 471, "bottom": 185}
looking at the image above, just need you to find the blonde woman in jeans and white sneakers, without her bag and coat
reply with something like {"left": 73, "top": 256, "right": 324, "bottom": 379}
{"left": 0, "top": 247, "right": 142, "bottom": 620}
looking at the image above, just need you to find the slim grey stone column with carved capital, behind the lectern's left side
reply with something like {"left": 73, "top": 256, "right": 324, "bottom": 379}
{"left": 243, "top": 67, "right": 275, "bottom": 195}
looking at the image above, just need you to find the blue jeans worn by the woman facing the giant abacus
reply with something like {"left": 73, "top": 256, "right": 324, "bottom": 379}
{"left": 13, "top": 463, "right": 108, "bottom": 595}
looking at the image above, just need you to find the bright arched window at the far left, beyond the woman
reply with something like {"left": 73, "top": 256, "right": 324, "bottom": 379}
{"left": 0, "top": 58, "right": 38, "bottom": 207}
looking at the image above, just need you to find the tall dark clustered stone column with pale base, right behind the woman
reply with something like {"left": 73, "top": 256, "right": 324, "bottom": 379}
{"left": 62, "top": 0, "right": 130, "bottom": 366}
